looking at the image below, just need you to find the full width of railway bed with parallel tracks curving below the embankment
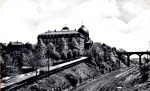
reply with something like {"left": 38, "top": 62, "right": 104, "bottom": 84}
{"left": 72, "top": 67, "right": 136, "bottom": 91}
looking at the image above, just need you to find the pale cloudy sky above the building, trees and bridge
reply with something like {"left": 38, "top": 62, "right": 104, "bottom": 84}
{"left": 0, "top": 0, "right": 150, "bottom": 51}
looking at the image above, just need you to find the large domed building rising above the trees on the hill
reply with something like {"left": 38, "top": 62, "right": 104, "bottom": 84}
{"left": 38, "top": 25, "right": 89, "bottom": 49}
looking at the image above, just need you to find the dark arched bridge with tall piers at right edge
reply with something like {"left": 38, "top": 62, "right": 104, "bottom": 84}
{"left": 118, "top": 51, "right": 150, "bottom": 67}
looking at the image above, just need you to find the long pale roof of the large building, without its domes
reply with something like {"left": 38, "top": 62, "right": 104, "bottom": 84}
{"left": 40, "top": 30, "right": 79, "bottom": 35}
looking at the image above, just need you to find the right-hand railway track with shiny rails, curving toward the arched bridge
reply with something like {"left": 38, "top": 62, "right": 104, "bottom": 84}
{"left": 95, "top": 67, "right": 136, "bottom": 91}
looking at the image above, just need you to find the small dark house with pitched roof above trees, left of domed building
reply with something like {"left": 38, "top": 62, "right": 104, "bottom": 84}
{"left": 7, "top": 41, "right": 25, "bottom": 50}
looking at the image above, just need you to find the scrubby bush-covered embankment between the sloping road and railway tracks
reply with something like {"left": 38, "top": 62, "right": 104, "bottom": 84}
{"left": 18, "top": 43, "right": 125, "bottom": 91}
